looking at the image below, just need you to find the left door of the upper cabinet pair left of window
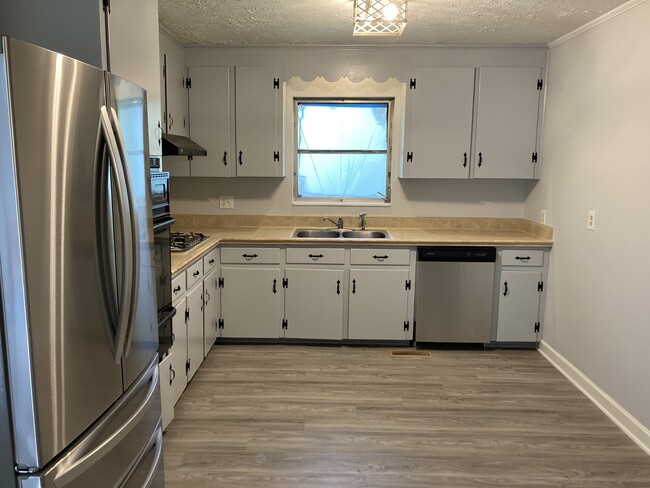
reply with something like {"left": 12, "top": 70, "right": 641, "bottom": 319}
{"left": 189, "top": 66, "right": 235, "bottom": 176}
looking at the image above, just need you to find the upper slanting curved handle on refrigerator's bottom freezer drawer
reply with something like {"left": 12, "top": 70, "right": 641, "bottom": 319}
{"left": 54, "top": 358, "right": 159, "bottom": 487}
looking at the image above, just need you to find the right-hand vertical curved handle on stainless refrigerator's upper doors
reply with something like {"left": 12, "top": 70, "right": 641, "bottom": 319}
{"left": 110, "top": 107, "right": 140, "bottom": 358}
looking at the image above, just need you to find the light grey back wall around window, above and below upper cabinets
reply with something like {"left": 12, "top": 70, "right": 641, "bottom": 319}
{"left": 161, "top": 45, "right": 547, "bottom": 217}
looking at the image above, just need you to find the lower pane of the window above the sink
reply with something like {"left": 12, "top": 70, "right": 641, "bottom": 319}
{"left": 298, "top": 154, "right": 387, "bottom": 200}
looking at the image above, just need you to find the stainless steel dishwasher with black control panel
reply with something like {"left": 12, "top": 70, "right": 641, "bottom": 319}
{"left": 415, "top": 246, "right": 496, "bottom": 347}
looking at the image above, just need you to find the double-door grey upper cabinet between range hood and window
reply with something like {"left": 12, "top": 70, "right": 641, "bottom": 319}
{"left": 186, "top": 66, "right": 284, "bottom": 177}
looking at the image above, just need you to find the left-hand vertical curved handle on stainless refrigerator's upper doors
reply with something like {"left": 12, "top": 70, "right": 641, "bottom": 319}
{"left": 100, "top": 106, "right": 134, "bottom": 364}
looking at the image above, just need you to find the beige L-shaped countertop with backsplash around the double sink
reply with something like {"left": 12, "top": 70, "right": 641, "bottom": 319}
{"left": 172, "top": 217, "right": 553, "bottom": 275}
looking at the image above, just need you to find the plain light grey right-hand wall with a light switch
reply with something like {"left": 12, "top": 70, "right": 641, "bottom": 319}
{"left": 525, "top": 2, "right": 650, "bottom": 428}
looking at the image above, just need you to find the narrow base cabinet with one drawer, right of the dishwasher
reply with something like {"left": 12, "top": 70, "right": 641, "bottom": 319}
{"left": 493, "top": 249, "right": 550, "bottom": 346}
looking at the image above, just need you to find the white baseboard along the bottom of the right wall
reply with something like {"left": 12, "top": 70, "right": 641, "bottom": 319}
{"left": 539, "top": 341, "right": 650, "bottom": 456}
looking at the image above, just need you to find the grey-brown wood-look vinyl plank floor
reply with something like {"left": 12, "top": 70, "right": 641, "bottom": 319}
{"left": 164, "top": 345, "right": 650, "bottom": 488}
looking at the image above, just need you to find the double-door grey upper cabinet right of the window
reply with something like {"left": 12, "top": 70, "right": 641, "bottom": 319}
{"left": 400, "top": 67, "right": 543, "bottom": 179}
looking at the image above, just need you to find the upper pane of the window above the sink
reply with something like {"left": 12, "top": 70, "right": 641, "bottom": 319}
{"left": 298, "top": 102, "right": 388, "bottom": 151}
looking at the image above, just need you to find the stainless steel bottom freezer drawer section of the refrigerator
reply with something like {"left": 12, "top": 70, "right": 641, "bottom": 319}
{"left": 19, "top": 357, "right": 163, "bottom": 488}
